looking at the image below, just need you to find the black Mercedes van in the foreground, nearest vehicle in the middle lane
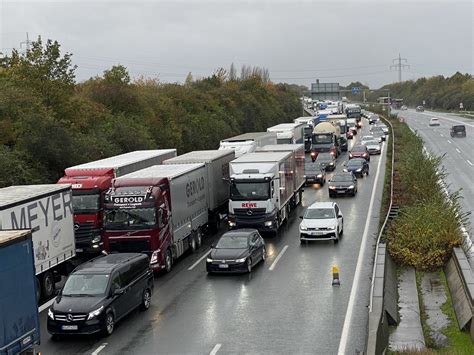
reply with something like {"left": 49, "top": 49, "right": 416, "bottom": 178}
{"left": 47, "top": 253, "right": 153, "bottom": 338}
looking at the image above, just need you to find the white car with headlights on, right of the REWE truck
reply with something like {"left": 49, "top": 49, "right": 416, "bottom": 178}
{"left": 300, "top": 202, "right": 344, "bottom": 243}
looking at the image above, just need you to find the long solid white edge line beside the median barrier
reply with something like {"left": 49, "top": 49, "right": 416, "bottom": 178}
{"left": 337, "top": 145, "right": 385, "bottom": 355}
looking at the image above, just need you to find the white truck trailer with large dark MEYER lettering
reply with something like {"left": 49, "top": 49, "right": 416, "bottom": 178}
{"left": 0, "top": 184, "right": 76, "bottom": 299}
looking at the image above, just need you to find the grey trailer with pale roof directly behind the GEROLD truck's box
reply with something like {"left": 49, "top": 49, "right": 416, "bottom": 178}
{"left": 163, "top": 149, "right": 235, "bottom": 232}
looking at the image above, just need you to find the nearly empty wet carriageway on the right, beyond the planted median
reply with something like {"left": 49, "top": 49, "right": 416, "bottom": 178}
{"left": 397, "top": 110, "right": 474, "bottom": 253}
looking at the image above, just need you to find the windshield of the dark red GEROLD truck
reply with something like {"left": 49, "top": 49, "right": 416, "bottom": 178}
{"left": 104, "top": 208, "right": 156, "bottom": 230}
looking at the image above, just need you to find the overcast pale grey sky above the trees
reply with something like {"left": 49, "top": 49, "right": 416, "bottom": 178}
{"left": 0, "top": 0, "right": 474, "bottom": 88}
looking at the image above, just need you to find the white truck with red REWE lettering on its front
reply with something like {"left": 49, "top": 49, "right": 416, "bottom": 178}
{"left": 228, "top": 151, "right": 303, "bottom": 233}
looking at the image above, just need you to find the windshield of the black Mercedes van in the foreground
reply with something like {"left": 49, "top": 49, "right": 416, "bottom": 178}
{"left": 61, "top": 274, "right": 109, "bottom": 296}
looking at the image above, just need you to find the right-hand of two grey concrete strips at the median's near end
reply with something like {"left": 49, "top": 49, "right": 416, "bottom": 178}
{"left": 421, "top": 272, "right": 449, "bottom": 347}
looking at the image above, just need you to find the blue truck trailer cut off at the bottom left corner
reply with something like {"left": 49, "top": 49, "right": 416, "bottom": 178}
{"left": 0, "top": 230, "right": 40, "bottom": 355}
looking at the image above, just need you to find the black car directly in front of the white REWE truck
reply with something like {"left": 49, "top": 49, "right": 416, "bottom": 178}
{"left": 206, "top": 229, "right": 267, "bottom": 274}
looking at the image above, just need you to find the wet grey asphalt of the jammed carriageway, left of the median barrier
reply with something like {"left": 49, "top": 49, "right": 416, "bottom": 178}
{"left": 39, "top": 121, "right": 387, "bottom": 355}
